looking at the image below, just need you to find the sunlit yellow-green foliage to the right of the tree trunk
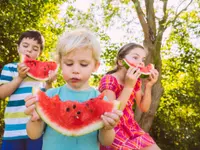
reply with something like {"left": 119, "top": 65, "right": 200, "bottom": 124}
{"left": 152, "top": 10, "right": 200, "bottom": 150}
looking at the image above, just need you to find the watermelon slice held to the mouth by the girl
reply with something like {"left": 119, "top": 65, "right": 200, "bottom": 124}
{"left": 122, "top": 59, "right": 154, "bottom": 78}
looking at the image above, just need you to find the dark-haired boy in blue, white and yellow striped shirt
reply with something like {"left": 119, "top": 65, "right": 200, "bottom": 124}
{"left": 0, "top": 30, "right": 54, "bottom": 150}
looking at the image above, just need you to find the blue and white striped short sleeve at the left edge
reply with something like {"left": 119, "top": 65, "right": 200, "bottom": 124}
{"left": 0, "top": 64, "right": 17, "bottom": 85}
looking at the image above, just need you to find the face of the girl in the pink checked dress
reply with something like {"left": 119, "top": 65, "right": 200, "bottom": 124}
{"left": 125, "top": 48, "right": 146, "bottom": 67}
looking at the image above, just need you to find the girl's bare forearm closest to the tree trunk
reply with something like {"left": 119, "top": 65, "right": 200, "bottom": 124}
{"left": 140, "top": 85, "right": 152, "bottom": 112}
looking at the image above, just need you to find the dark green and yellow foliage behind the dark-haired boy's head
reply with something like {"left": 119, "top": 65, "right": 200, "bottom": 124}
{"left": 0, "top": 0, "right": 64, "bottom": 143}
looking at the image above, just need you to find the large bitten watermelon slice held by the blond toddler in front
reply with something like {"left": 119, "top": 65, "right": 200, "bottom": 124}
{"left": 36, "top": 90, "right": 120, "bottom": 136}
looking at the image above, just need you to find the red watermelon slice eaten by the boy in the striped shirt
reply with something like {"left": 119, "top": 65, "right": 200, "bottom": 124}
{"left": 21, "top": 55, "right": 58, "bottom": 81}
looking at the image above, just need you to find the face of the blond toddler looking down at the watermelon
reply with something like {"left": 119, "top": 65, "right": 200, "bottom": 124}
{"left": 61, "top": 49, "right": 99, "bottom": 90}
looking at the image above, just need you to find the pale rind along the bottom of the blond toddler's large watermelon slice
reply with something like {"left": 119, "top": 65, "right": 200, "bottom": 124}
{"left": 36, "top": 96, "right": 120, "bottom": 136}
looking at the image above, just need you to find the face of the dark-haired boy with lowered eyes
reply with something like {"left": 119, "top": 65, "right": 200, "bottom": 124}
{"left": 18, "top": 38, "right": 41, "bottom": 59}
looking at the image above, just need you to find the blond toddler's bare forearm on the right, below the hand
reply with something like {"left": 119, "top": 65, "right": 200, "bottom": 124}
{"left": 99, "top": 129, "right": 115, "bottom": 146}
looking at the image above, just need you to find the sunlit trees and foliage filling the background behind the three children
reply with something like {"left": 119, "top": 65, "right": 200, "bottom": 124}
{"left": 0, "top": 0, "right": 200, "bottom": 150}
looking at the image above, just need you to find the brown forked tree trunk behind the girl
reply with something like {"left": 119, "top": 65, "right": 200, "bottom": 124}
{"left": 132, "top": 0, "right": 167, "bottom": 132}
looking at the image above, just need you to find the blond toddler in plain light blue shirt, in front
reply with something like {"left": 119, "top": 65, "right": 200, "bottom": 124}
{"left": 25, "top": 29, "right": 122, "bottom": 150}
